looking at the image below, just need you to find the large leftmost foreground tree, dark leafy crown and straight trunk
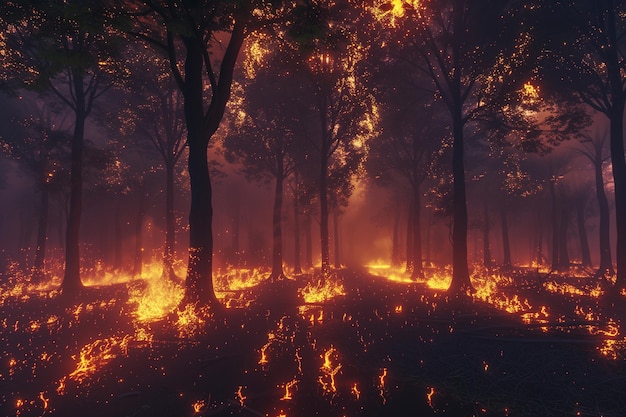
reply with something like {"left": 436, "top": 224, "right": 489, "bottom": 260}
{"left": 2, "top": 0, "right": 124, "bottom": 297}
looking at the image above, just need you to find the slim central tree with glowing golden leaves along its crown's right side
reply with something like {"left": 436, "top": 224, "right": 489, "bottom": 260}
{"left": 289, "top": 2, "right": 378, "bottom": 276}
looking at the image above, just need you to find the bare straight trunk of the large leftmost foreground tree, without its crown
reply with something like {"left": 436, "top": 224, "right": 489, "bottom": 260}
{"left": 61, "top": 74, "right": 87, "bottom": 298}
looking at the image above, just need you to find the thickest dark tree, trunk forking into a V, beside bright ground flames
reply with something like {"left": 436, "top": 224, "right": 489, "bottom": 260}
{"left": 127, "top": 0, "right": 292, "bottom": 308}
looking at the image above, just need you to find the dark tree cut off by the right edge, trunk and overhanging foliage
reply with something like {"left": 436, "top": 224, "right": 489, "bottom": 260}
{"left": 541, "top": 0, "right": 626, "bottom": 293}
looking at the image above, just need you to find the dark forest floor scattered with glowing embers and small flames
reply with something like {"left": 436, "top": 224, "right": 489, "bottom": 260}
{"left": 0, "top": 270, "right": 626, "bottom": 417}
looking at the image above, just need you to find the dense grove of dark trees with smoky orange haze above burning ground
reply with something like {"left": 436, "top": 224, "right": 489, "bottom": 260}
{"left": 0, "top": 0, "right": 626, "bottom": 309}
